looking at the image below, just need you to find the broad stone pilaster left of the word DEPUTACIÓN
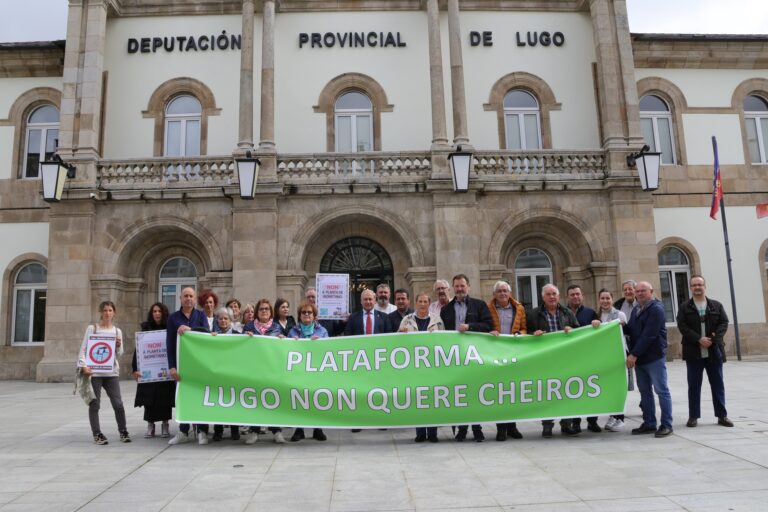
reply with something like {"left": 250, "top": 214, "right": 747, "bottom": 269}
{"left": 58, "top": 0, "right": 107, "bottom": 182}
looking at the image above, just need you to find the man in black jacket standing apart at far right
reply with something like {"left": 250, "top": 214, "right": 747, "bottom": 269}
{"left": 677, "top": 275, "right": 733, "bottom": 427}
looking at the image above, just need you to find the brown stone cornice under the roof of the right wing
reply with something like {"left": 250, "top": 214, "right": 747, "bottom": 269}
{"left": 632, "top": 34, "right": 768, "bottom": 69}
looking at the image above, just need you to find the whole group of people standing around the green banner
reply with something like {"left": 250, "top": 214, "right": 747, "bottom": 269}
{"left": 78, "top": 274, "right": 733, "bottom": 445}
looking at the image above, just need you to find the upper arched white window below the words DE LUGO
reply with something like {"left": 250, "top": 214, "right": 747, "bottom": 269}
{"left": 504, "top": 89, "right": 541, "bottom": 150}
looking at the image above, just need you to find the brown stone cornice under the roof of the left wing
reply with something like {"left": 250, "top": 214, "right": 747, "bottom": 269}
{"left": 0, "top": 41, "right": 64, "bottom": 78}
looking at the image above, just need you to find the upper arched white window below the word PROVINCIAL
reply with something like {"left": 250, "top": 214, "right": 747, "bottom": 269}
{"left": 334, "top": 91, "right": 373, "bottom": 153}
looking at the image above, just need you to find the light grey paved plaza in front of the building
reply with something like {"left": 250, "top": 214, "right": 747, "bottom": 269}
{"left": 0, "top": 361, "right": 768, "bottom": 512}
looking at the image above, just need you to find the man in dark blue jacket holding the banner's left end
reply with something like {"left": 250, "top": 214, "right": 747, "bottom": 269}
{"left": 165, "top": 288, "right": 208, "bottom": 445}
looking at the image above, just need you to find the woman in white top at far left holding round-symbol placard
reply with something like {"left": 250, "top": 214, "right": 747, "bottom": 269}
{"left": 77, "top": 300, "right": 131, "bottom": 445}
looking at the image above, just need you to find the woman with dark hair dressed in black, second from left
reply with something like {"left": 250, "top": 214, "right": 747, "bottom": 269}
{"left": 132, "top": 302, "right": 176, "bottom": 438}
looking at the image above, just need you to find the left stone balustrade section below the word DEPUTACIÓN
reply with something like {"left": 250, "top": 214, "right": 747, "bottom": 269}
{"left": 98, "top": 156, "right": 235, "bottom": 189}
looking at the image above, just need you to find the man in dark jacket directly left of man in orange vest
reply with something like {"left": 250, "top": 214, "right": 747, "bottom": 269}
{"left": 440, "top": 274, "right": 493, "bottom": 443}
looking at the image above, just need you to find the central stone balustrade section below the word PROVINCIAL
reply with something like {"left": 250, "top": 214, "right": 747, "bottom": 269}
{"left": 277, "top": 152, "right": 432, "bottom": 183}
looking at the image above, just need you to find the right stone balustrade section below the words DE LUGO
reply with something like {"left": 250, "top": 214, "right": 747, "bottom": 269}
{"left": 474, "top": 150, "right": 605, "bottom": 179}
